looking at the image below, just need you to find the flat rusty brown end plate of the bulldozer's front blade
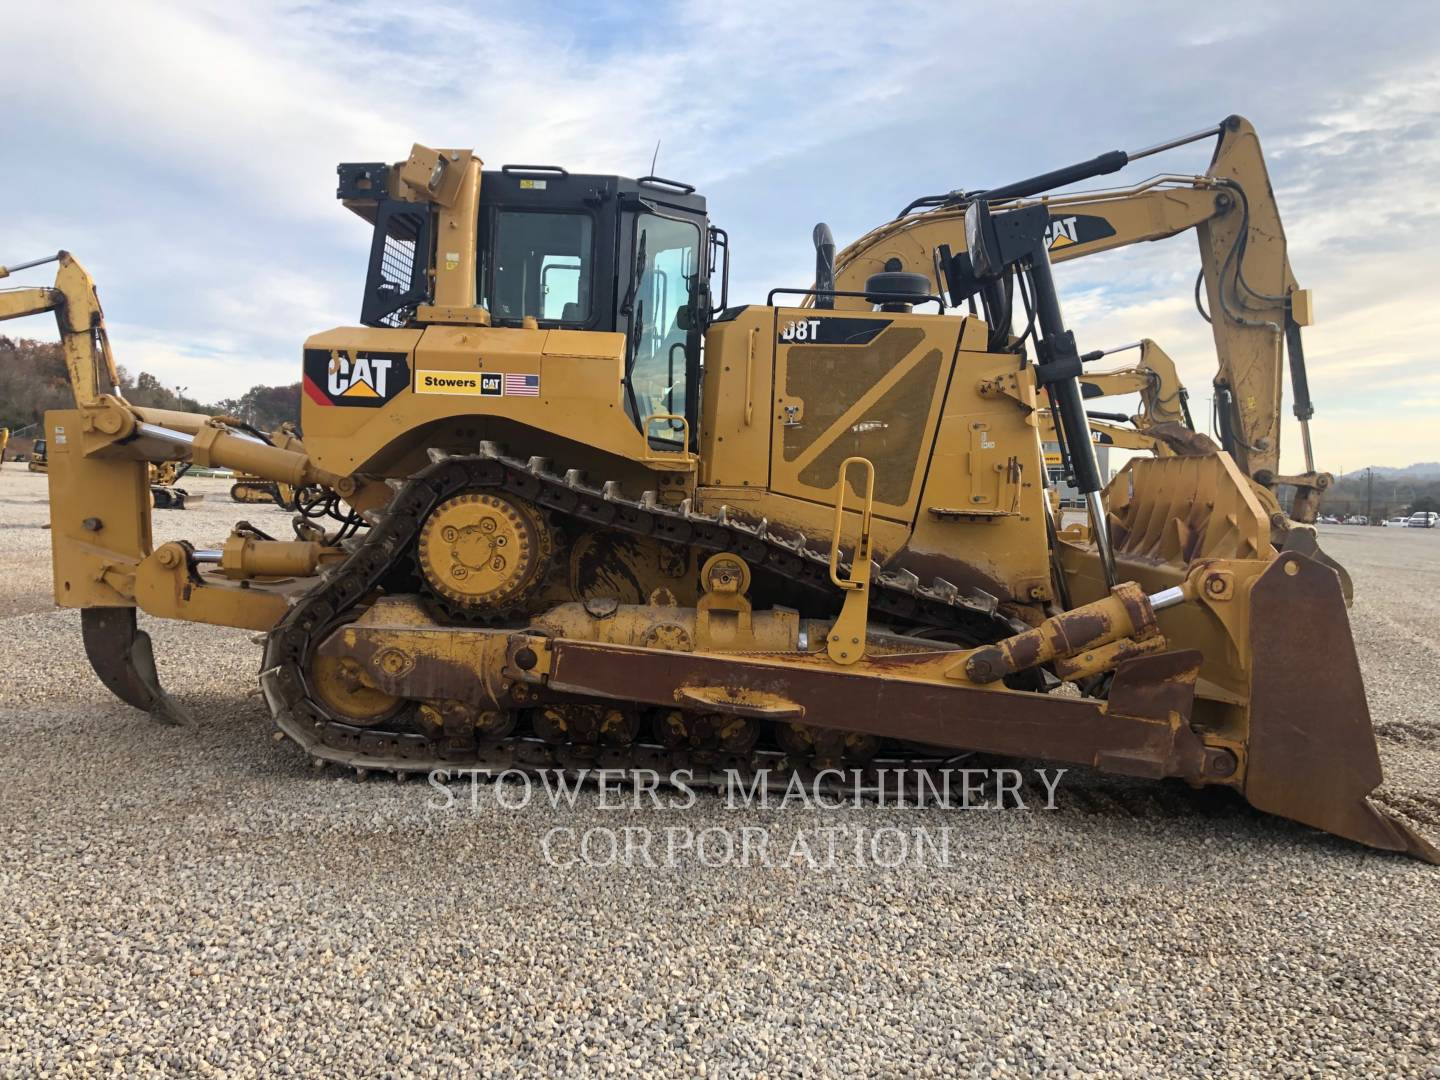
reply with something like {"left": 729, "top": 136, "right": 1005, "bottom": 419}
{"left": 1244, "top": 553, "right": 1440, "bottom": 863}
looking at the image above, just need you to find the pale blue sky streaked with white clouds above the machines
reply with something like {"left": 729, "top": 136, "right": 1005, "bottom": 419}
{"left": 0, "top": 0, "right": 1440, "bottom": 472}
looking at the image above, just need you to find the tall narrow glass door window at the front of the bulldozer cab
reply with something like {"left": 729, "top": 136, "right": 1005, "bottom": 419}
{"left": 626, "top": 213, "right": 700, "bottom": 442}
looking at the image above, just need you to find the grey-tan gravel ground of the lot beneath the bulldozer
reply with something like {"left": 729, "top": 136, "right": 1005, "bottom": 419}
{"left": 0, "top": 465, "right": 1440, "bottom": 1077}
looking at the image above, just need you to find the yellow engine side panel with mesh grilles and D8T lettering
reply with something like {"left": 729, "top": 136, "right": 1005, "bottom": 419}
{"left": 770, "top": 308, "right": 962, "bottom": 523}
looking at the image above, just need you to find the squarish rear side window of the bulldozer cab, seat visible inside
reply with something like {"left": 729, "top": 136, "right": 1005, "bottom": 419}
{"left": 480, "top": 210, "right": 595, "bottom": 325}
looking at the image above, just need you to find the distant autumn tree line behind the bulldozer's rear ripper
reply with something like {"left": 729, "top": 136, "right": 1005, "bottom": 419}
{"left": 0, "top": 336, "right": 300, "bottom": 431}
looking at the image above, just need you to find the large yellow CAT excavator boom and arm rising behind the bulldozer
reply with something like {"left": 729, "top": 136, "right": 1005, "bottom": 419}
{"left": 816, "top": 117, "right": 1332, "bottom": 532}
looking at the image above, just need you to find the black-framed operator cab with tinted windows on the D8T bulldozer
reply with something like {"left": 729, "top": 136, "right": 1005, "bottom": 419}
{"left": 338, "top": 164, "right": 714, "bottom": 449}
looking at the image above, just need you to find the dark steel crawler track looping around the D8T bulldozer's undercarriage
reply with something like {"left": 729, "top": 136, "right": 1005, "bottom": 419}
{"left": 261, "top": 444, "right": 1022, "bottom": 786}
